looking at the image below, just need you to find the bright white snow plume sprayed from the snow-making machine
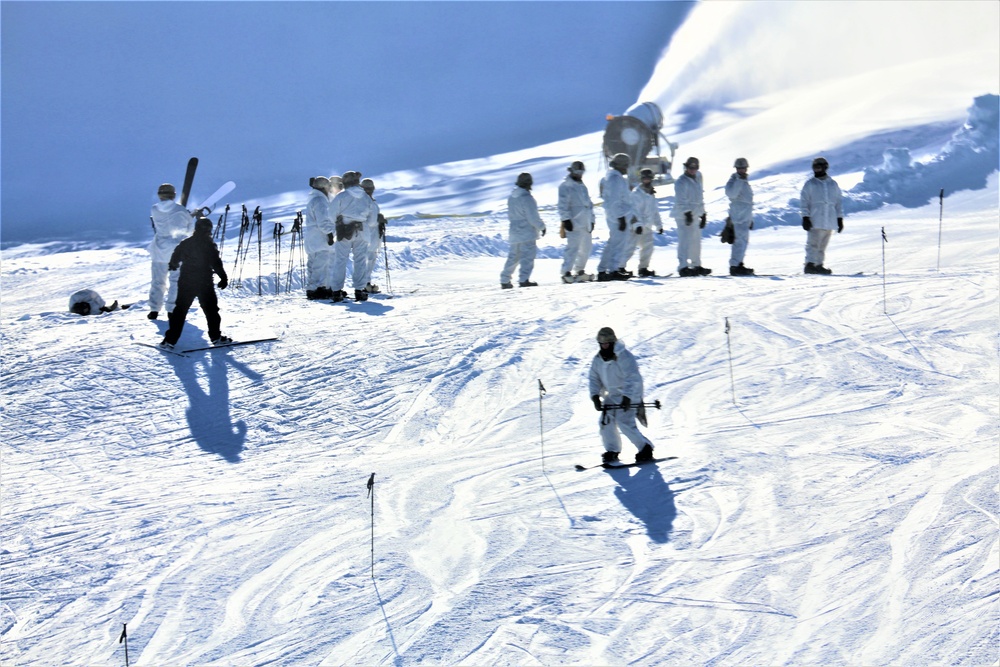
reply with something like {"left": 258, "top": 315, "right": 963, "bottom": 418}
{"left": 636, "top": 0, "right": 997, "bottom": 132}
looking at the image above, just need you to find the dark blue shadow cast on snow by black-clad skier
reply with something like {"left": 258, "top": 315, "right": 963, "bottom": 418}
{"left": 161, "top": 326, "right": 261, "bottom": 463}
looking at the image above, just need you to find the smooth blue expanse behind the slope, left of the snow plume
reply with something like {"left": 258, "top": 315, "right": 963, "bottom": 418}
{"left": 0, "top": 2, "right": 692, "bottom": 242}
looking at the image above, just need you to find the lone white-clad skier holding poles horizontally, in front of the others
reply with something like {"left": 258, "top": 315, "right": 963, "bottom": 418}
{"left": 590, "top": 327, "right": 653, "bottom": 463}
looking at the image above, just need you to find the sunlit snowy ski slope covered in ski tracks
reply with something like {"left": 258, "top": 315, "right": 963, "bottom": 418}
{"left": 0, "top": 6, "right": 1000, "bottom": 666}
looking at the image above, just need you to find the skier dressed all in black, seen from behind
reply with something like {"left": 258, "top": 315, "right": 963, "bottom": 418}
{"left": 160, "top": 218, "right": 233, "bottom": 349}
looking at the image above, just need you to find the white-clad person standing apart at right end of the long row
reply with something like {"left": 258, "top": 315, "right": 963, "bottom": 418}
{"left": 800, "top": 157, "right": 844, "bottom": 276}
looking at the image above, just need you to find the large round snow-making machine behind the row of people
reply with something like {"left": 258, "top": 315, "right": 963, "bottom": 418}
{"left": 604, "top": 102, "right": 677, "bottom": 185}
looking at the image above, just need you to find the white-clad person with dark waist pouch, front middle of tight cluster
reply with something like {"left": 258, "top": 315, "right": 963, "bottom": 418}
{"left": 330, "top": 171, "right": 373, "bottom": 301}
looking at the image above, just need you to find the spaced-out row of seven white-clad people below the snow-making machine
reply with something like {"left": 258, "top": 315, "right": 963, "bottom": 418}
{"left": 500, "top": 153, "right": 844, "bottom": 289}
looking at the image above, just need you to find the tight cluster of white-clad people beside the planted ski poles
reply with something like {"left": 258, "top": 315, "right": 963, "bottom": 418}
{"left": 303, "top": 171, "right": 385, "bottom": 302}
